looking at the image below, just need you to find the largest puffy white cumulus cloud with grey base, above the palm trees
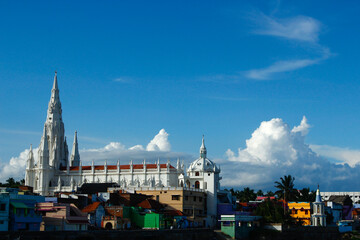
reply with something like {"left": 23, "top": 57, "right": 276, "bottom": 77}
{"left": 221, "top": 117, "right": 360, "bottom": 191}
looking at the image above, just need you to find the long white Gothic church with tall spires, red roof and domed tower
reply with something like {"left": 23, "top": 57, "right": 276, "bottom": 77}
{"left": 25, "top": 72, "right": 221, "bottom": 226}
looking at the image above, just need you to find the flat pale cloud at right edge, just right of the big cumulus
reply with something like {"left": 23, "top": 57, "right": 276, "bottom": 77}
{"left": 310, "top": 145, "right": 360, "bottom": 167}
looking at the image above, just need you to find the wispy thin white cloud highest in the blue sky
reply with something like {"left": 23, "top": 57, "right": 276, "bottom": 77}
{"left": 255, "top": 13, "right": 321, "bottom": 43}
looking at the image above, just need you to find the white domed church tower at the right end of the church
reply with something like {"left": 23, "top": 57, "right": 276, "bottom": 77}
{"left": 186, "top": 136, "right": 221, "bottom": 227}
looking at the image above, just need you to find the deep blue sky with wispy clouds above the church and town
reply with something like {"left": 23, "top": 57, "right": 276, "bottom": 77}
{"left": 0, "top": 1, "right": 360, "bottom": 191}
